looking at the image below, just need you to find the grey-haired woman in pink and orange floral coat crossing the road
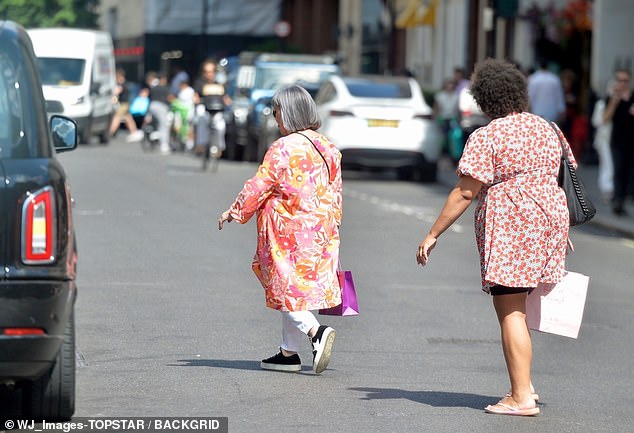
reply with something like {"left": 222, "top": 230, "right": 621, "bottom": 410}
{"left": 218, "top": 85, "right": 342, "bottom": 373}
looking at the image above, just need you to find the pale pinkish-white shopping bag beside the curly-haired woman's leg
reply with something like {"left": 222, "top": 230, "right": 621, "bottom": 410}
{"left": 526, "top": 272, "right": 590, "bottom": 338}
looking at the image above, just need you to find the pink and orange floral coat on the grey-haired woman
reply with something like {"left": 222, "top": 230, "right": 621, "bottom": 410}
{"left": 230, "top": 131, "right": 342, "bottom": 311}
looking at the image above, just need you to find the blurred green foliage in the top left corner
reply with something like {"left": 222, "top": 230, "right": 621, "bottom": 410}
{"left": 0, "top": 0, "right": 99, "bottom": 28}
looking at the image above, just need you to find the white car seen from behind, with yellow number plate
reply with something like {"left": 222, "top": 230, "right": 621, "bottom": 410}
{"left": 315, "top": 75, "right": 442, "bottom": 181}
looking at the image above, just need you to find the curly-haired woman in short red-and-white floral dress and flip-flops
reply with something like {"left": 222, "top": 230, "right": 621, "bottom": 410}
{"left": 416, "top": 59, "right": 576, "bottom": 415}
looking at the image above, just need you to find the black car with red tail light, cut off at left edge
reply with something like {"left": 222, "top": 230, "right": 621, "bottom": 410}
{"left": 0, "top": 21, "right": 77, "bottom": 420}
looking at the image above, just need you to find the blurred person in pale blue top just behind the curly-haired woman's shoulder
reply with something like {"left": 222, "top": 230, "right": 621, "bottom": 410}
{"left": 528, "top": 62, "right": 566, "bottom": 122}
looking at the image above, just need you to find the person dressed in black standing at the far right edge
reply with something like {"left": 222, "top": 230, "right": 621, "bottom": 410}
{"left": 603, "top": 69, "right": 634, "bottom": 216}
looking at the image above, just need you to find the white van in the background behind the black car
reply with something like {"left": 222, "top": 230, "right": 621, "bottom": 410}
{"left": 28, "top": 28, "right": 116, "bottom": 143}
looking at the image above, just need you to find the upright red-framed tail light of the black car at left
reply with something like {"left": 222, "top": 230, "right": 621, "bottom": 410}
{"left": 22, "top": 186, "right": 55, "bottom": 265}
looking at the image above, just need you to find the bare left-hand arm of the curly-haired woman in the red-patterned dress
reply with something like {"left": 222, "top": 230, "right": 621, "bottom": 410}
{"left": 416, "top": 176, "right": 482, "bottom": 265}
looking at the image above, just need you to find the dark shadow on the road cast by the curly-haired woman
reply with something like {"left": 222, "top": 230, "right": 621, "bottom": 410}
{"left": 350, "top": 388, "right": 500, "bottom": 409}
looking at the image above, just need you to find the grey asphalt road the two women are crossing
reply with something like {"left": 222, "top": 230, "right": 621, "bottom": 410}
{"left": 12, "top": 139, "right": 634, "bottom": 433}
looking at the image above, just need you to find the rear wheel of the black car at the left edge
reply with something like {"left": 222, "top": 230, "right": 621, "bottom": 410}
{"left": 25, "top": 313, "right": 75, "bottom": 420}
